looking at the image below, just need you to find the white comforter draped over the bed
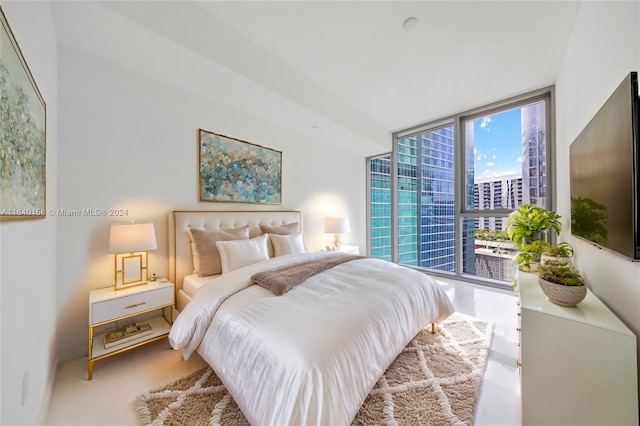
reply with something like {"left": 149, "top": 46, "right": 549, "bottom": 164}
{"left": 169, "top": 252, "right": 453, "bottom": 425}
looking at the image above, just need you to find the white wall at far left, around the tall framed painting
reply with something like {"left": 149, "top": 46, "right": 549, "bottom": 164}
{"left": 0, "top": 1, "right": 58, "bottom": 425}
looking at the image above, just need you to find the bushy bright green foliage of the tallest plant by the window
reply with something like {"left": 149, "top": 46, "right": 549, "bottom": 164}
{"left": 506, "top": 204, "right": 562, "bottom": 251}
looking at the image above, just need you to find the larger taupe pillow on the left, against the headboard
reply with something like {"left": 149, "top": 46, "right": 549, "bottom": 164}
{"left": 189, "top": 226, "right": 249, "bottom": 277}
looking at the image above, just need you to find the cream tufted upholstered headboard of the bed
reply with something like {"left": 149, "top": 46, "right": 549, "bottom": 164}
{"left": 169, "top": 210, "right": 302, "bottom": 291}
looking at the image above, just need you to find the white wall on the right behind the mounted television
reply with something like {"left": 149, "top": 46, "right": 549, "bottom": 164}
{"left": 556, "top": 2, "right": 640, "bottom": 382}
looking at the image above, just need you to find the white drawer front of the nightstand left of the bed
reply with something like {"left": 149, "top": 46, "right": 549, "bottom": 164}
{"left": 91, "top": 286, "right": 173, "bottom": 324}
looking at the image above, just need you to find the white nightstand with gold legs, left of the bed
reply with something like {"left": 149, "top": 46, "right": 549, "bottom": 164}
{"left": 88, "top": 280, "right": 174, "bottom": 380}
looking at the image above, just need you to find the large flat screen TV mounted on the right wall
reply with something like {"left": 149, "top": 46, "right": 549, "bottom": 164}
{"left": 570, "top": 72, "right": 640, "bottom": 261}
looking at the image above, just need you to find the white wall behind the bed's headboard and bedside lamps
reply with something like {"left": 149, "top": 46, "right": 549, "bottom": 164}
{"left": 57, "top": 46, "right": 365, "bottom": 360}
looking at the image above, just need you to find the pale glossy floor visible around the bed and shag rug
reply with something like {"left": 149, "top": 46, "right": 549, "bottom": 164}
{"left": 45, "top": 281, "right": 520, "bottom": 426}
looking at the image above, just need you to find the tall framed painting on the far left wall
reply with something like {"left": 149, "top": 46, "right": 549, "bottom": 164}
{"left": 0, "top": 8, "right": 46, "bottom": 218}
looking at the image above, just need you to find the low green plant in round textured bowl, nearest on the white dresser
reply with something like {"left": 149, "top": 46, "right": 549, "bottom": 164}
{"left": 538, "top": 261, "right": 587, "bottom": 306}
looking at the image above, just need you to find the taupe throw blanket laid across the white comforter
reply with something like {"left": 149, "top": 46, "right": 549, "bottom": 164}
{"left": 251, "top": 254, "right": 364, "bottom": 296}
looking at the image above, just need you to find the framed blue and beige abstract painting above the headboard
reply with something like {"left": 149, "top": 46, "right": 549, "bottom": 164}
{"left": 198, "top": 129, "right": 282, "bottom": 204}
